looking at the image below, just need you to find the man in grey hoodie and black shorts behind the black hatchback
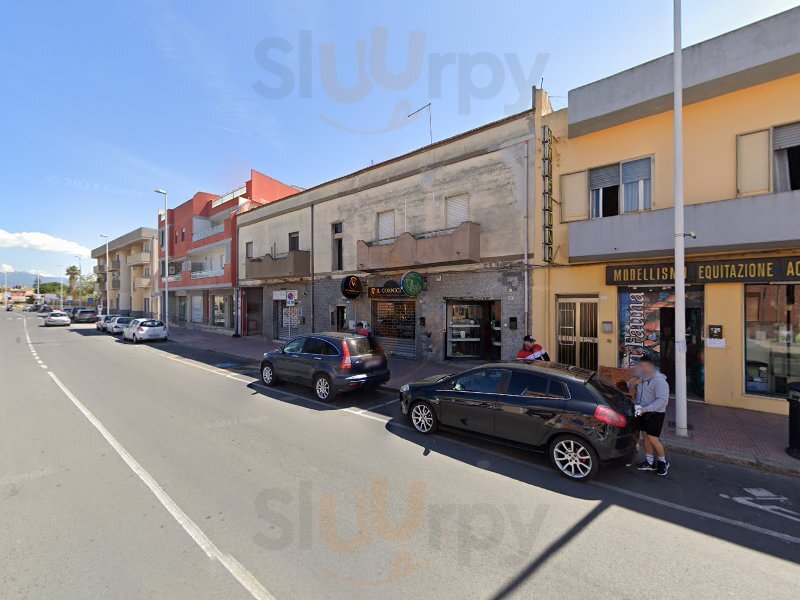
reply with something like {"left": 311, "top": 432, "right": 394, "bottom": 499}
{"left": 628, "top": 357, "right": 669, "bottom": 477}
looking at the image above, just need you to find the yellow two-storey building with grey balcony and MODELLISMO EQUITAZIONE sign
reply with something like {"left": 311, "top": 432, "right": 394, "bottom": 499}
{"left": 532, "top": 9, "right": 800, "bottom": 413}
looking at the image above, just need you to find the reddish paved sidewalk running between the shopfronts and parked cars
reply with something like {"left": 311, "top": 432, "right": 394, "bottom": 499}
{"left": 169, "top": 325, "right": 800, "bottom": 476}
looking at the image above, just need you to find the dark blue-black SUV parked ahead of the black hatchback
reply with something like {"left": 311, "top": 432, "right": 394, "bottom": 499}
{"left": 261, "top": 333, "right": 390, "bottom": 402}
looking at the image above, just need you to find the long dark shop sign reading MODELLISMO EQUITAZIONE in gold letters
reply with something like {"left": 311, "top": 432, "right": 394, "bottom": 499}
{"left": 606, "top": 256, "right": 800, "bottom": 285}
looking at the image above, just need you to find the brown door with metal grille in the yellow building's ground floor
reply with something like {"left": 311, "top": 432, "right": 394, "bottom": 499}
{"left": 556, "top": 298, "right": 598, "bottom": 371}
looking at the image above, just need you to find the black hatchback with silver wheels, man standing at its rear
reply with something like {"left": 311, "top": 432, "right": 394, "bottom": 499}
{"left": 400, "top": 362, "right": 635, "bottom": 481}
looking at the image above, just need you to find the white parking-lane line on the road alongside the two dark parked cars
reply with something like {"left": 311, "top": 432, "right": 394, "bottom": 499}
{"left": 131, "top": 340, "right": 800, "bottom": 544}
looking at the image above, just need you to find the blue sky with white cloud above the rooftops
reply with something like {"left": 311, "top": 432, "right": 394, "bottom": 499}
{"left": 0, "top": 0, "right": 797, "bottom": 274}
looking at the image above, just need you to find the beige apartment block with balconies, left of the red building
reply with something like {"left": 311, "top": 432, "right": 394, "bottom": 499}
{"left": 92, "top": 227, "right": 158, "bottom": 317}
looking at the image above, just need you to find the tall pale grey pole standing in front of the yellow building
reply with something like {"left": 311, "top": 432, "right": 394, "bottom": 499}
{"left": 672, "top": 0, "right": 689, "bottom": 437}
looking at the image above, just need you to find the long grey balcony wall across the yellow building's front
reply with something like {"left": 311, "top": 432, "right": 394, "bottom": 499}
{"left": 568, "top": 190, "right": 800, "bottom": 262}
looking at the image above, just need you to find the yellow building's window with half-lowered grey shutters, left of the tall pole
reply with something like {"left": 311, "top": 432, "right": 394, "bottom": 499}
{"left": 589, "top": 157, "right": 653, "bottom": 219}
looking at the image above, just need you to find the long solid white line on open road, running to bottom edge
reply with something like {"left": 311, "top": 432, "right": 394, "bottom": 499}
{"left": 48, "top": 371, "right": 274, "bottom": 600}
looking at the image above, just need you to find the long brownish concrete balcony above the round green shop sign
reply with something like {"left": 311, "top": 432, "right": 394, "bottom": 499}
{"left": 356, "top": 221, "right": 481, "bottom": 271}
